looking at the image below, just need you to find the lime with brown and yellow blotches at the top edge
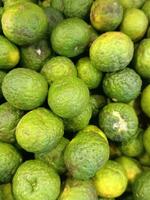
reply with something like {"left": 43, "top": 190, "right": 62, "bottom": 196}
{"left": 90, "top": 0, "right": 123, "bottom": 32}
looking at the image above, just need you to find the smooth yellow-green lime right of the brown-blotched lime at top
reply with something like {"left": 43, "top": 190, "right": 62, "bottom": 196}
{"left": 120, "top": 8, "right": 148, "bottom": 42}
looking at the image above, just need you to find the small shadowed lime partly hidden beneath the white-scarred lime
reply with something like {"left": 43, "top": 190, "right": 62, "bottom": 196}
{"left": 120, "top": 128, "right": 144, "bottom": 157}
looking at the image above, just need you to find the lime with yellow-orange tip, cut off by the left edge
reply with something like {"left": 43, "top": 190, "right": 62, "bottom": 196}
{"left": 0, "top": 36, "right": 20, "bottom": 70}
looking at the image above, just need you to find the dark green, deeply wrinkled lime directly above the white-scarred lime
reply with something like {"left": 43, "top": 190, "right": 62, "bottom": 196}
{"left": 103, "top": 68, "right": 142, "bottom": 103}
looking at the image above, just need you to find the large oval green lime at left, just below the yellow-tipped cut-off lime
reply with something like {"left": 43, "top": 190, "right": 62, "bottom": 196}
{"left": 2, "top": 68, "right": 48, "bottom": 110}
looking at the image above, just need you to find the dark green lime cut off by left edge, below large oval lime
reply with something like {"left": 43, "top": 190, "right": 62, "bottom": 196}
{"left": 0, "top": 102, "right": 23, "bottom": 143}
